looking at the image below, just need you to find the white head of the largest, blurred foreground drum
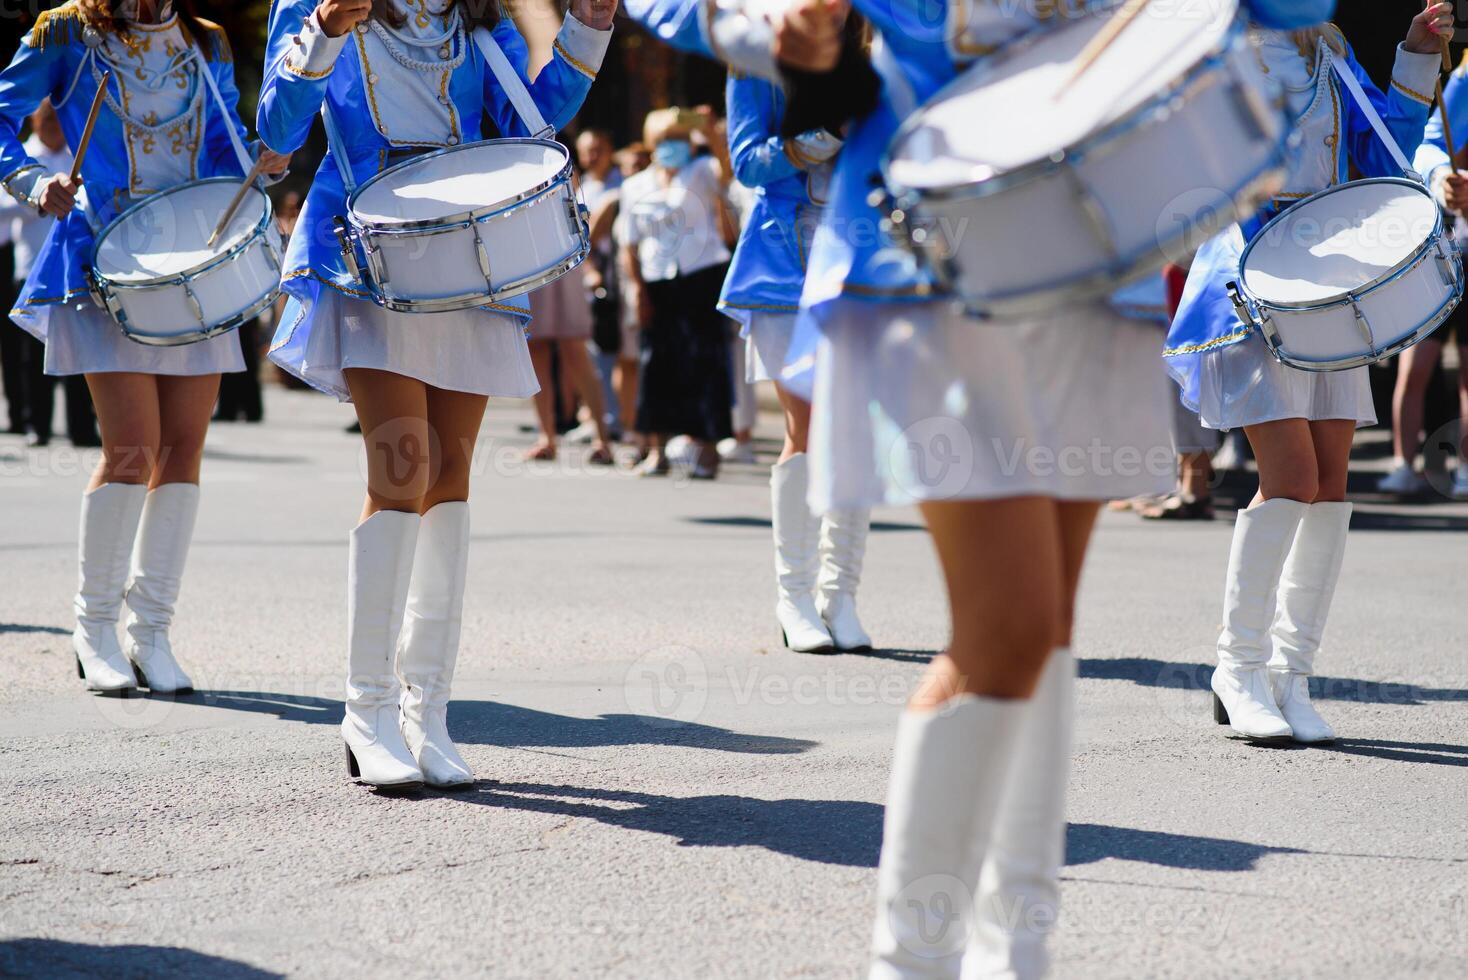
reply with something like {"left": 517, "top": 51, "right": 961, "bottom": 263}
{"left": 888, "top": 0, "right": 1238, "bottom": 191}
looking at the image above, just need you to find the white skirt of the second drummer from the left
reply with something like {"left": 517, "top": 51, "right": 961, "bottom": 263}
{"left": 270, "top": 288, "right": 540, "bottom": 402}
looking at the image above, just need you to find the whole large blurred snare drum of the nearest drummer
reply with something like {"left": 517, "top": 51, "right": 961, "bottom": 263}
{"left": 876, "top": 0, "right": 1289, "bottom": 315}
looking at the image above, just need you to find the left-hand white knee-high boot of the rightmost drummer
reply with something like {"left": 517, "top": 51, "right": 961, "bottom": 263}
{"left": 1213, "top": 497, "right": 1309, "bottom": 741}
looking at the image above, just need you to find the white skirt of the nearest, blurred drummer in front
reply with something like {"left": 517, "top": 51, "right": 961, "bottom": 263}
{"left": 810, "top": 299, "right": 1176, "bottom": 511}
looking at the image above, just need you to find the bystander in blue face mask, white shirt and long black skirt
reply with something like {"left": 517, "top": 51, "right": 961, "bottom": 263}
{"left": 618, "top": 109, "right": 735, "bottom": 480}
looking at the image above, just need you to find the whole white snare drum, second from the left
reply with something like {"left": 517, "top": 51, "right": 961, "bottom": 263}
{"left": 336, "top": 139, "right": 592, "bottom": 312}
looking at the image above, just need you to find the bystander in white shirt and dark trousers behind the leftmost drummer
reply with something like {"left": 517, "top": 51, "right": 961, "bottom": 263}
{"left": 0, "top": 100, "right": 101, "bottom": 447}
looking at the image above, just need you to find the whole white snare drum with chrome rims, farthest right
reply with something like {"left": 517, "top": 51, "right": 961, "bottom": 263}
{"left": 1229, "top": 178, "right": 1464, "bottom": 371}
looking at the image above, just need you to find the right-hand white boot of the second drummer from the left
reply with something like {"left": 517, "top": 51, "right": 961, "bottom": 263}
{"left": 398, "top": 500, "right": 474, "bottom": 789}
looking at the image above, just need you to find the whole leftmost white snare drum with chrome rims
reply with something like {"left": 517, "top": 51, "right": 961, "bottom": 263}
{"left": 87, "top": 178, "right": 282, "bottom": 348}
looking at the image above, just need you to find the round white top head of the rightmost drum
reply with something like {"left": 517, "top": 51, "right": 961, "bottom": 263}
{"left": 1243, "top": 180, "right": 1437, "bottom": 305}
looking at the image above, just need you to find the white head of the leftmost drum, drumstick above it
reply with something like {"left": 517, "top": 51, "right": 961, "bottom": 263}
{"left": 95, "top": 180, "right": 269, "bottom": 283}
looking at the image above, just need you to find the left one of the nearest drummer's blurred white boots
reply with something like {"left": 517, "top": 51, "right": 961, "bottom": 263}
{"left": 871, "top": 694, "right": 1029, "bottom": 980}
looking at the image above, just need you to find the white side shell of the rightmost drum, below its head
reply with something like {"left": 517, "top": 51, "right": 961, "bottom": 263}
{"left": 1251, "top": 233, "right": 1464, "bottom": 371}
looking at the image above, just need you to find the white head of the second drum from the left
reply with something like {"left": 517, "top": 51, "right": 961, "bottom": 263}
{"left": 352, "top": 139, "right": 570, "bottom": 224}
